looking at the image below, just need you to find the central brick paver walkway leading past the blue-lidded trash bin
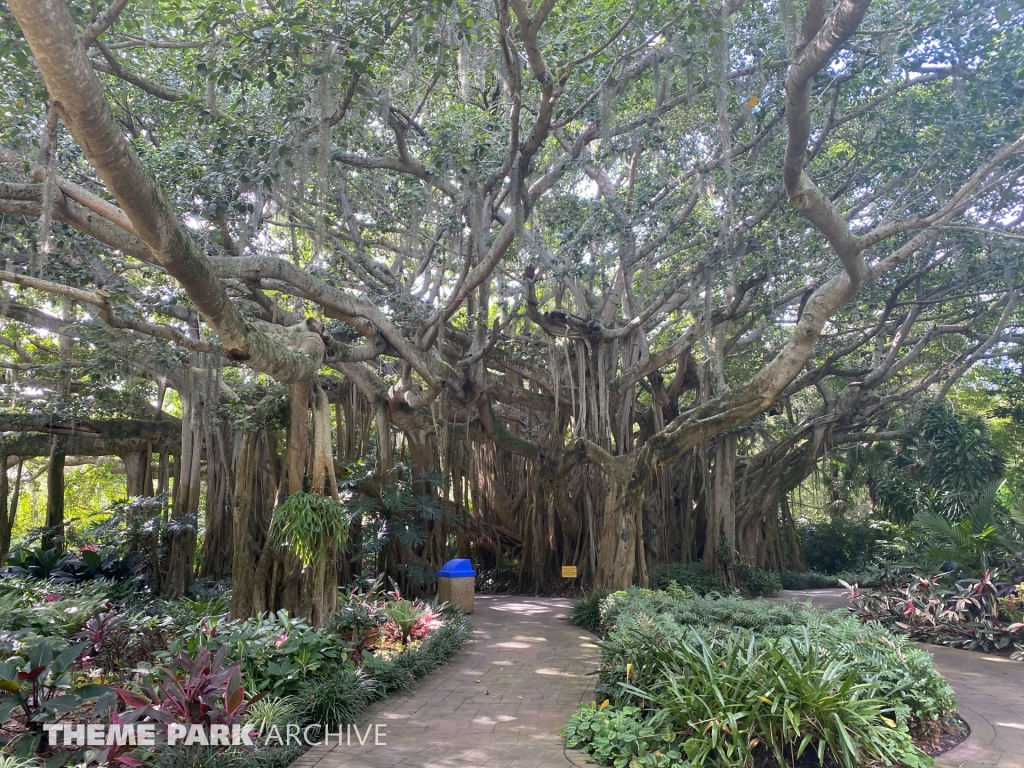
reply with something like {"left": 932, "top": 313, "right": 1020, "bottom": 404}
{"left": 292, "top": 595, "right": 597, "bottom": 768}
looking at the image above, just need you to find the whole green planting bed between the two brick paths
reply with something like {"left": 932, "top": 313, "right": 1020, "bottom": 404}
{"left": 563, "top": 587, "right": 953, "bottom": 768}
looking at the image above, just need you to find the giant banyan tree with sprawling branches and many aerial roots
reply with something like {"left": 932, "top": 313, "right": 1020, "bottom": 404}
{"left": 0, "top": 0, "right": 1024, "bottom": 621}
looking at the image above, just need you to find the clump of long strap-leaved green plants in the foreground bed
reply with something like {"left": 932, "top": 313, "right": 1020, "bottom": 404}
{"left": 633, "top": 632, "right": 931, "bottom": 768}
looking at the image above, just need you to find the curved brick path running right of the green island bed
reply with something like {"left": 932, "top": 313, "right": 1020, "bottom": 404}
{"left": 781, "top": 590, "right": 1024, "bottom": 768}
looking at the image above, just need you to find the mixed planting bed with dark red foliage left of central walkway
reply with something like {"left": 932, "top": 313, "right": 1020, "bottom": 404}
{"left": 0, "top": 579, "right": 469, "bottom": 768}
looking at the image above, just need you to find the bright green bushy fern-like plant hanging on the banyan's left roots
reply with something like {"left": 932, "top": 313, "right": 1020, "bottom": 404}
{"left": 270, "top": 492, "right": 348, "bottom": 565}
